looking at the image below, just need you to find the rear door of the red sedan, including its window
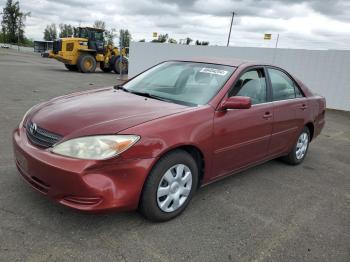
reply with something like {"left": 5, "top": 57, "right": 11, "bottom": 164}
{"left": 267, "top": 67, "right": 309, "bottom": 156}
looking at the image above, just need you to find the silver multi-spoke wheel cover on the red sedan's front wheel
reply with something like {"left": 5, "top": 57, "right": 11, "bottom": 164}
{"left": 157, "top": 164, "right": 192, "bottom": 213}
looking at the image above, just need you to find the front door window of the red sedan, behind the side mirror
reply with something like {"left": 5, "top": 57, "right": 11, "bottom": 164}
{"left": 230, "top": 69, "right": 267, "bottom": 105}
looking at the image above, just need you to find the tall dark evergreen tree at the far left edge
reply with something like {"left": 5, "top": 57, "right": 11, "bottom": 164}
{"left": 1, "top": 0, "right": 30, "bottom": 43}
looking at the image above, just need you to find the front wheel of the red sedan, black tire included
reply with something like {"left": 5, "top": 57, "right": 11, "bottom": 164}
{"left": 139, "top": 150, "right": 198, "bottom": 222}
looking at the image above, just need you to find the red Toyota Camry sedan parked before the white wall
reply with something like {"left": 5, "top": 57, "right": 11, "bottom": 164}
{"left": 13, "top": 59, "right": 325, "bottom": 221}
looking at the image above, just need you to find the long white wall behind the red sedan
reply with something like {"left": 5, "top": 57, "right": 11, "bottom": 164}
{"left": 129, "top": 42, "right": 350, "bottom": 111}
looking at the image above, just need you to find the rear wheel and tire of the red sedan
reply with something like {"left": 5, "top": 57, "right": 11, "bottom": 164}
{"left": 282, "top": 126, "right": 310, "bottom": 165}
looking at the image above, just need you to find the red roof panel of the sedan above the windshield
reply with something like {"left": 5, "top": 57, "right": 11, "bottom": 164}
{"left": 171, "top": 57, "right": 270, "bottom": 67}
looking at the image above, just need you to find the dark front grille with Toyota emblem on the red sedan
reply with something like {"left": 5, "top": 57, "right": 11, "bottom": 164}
{"left": 26, "top": 122, "right": 62, "bottom": 148}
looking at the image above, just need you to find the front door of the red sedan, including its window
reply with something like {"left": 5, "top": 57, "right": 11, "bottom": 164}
{"left": 213, "top": 67, "right": 273, "bottom": 179}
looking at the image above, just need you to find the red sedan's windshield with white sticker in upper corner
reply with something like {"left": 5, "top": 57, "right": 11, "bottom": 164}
{"left": 123, "top": 61, "right": 236, "bottom": 106}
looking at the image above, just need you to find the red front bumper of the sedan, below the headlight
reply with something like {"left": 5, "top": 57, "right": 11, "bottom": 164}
{"left": 13, "top": 128, "right": 155, "bottom": 212}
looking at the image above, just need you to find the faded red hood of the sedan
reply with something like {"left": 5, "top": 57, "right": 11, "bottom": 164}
{"left": 28, "top": 87, "right": 189, "bottom": 138}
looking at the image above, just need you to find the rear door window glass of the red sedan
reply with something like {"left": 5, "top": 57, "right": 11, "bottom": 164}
{"left": 267, "top": 68, "right": 303, "bottom": 101}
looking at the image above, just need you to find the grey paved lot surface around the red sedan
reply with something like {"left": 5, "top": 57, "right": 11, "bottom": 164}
{"left": 0, "top": 50, "right": 350, "bottom": 262}
